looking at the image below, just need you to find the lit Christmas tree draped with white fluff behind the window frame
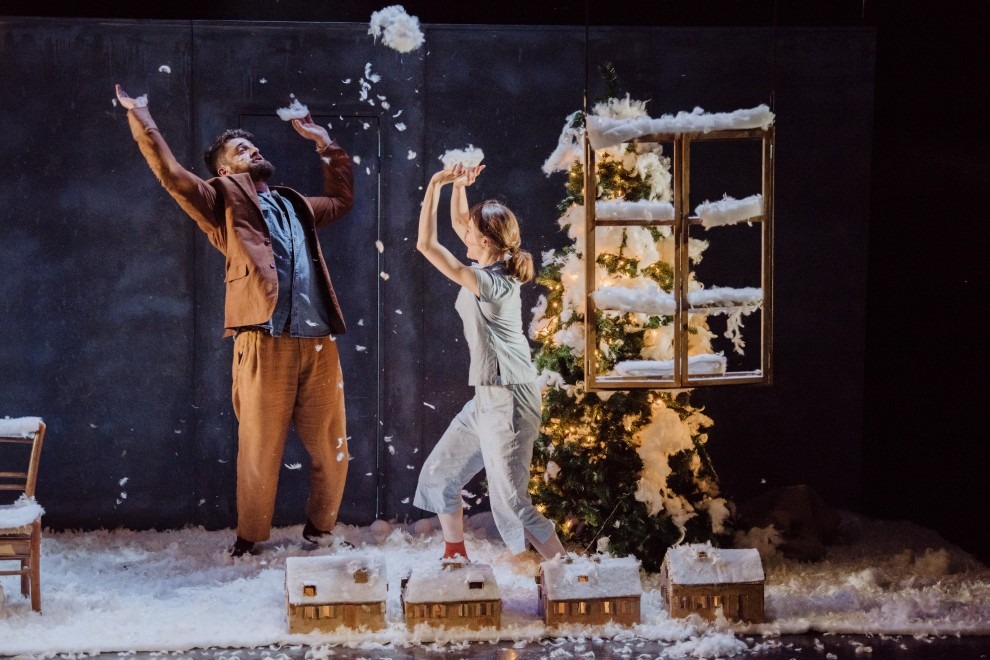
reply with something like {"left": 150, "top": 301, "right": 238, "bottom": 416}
{"left": 530, "top": 89, "right": 730, "bottom": 570}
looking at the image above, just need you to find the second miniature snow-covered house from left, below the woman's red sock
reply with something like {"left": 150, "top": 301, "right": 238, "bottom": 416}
{"left": 402, "top": 561, "right": 502, "bottom": 630}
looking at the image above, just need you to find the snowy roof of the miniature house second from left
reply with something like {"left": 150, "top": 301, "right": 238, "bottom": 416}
{"left": 405, "top": 563, "right": 502, "bottom": 603}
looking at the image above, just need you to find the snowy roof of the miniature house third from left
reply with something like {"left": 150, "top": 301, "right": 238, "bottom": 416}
{"left": 540, "top": 557, "right": 643, "bottom": 600}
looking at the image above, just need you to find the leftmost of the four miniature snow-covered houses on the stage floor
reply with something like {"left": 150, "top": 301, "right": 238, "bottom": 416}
{"left": 285, "top": 557, "right": 388, "bottom": 633}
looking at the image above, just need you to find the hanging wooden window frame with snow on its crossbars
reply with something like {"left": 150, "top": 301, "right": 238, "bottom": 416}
{"left": 584, "top": 119, "right": 774, "bottom": 390}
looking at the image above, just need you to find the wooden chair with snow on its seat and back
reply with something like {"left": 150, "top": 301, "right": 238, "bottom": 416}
{"left": 0, "top": 417, "right": 45, "bottom": 612}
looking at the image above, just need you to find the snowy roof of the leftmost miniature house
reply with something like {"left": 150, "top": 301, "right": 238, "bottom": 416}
{"left": 285, "top": 557, "right": 388, "bottom": 605}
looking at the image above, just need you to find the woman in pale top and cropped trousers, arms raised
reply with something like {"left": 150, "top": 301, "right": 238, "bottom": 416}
{"left": 413, "top": 165, "right": 566, "bottom": 559}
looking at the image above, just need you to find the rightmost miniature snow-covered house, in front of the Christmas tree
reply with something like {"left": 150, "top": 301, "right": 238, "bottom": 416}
{"left": 660, "top": 543, "right": 766, "bottom": 623}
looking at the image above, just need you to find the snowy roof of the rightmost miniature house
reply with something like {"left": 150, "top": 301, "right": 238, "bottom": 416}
{"left": 664, "top": 543, "right": 764, "bottom": 584}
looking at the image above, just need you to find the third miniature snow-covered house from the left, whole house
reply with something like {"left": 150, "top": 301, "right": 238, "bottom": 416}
{"left": 536, "top": 555, "right": 643, "bottom": 626}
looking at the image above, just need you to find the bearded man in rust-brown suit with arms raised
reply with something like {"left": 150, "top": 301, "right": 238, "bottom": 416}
{"left": 116, "top": 85, "right": 354, "bottom": 557}
